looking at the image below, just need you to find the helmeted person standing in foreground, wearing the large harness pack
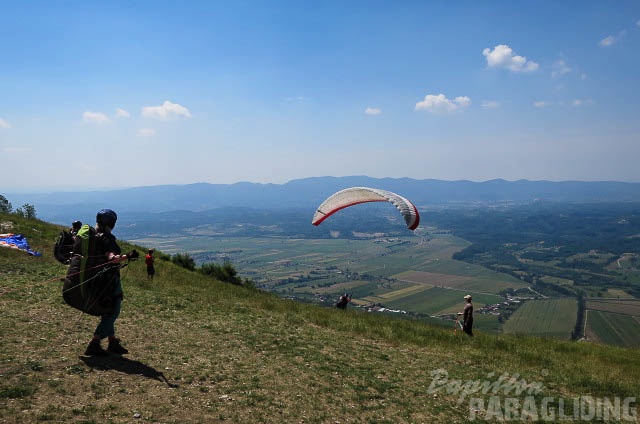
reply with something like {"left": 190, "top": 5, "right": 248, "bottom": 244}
{"left": 85, "top": 209, "right": 138, "bottom": 356}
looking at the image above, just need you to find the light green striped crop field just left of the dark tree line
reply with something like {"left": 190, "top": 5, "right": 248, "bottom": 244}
{"left": 504, "top": 298, "right": 578, "bottom": 339}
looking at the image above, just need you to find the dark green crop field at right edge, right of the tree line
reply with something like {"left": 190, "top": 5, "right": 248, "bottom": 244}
{"left": 586, "top": 310, "right": 640, "bottom": 348}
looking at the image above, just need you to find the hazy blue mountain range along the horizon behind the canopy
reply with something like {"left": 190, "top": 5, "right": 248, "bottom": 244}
{"left": 4, "top": 176, "right": 640, "bottom": 227}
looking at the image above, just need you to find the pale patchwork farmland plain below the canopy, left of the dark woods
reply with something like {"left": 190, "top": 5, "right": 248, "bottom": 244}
{"left": 135, "top": 234, "right": 527, "bottom": 326}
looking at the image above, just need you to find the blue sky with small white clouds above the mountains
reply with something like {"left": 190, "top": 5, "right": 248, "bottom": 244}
{"left": 0, "top": 0, "right": 640, "bottom": 192}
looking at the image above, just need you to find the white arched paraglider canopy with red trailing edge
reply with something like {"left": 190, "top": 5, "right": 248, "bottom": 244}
{"left": 311, "top": 187, "right": 420, "bottom": 231}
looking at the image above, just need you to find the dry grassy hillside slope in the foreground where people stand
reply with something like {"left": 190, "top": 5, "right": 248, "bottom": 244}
{"left": 0, "top": 215, "right": 640, "bottom": 423}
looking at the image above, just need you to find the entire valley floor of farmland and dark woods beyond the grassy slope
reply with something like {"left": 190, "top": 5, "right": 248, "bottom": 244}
{"left": 126, "top": 204, "right": 640, "bottom": 348}
